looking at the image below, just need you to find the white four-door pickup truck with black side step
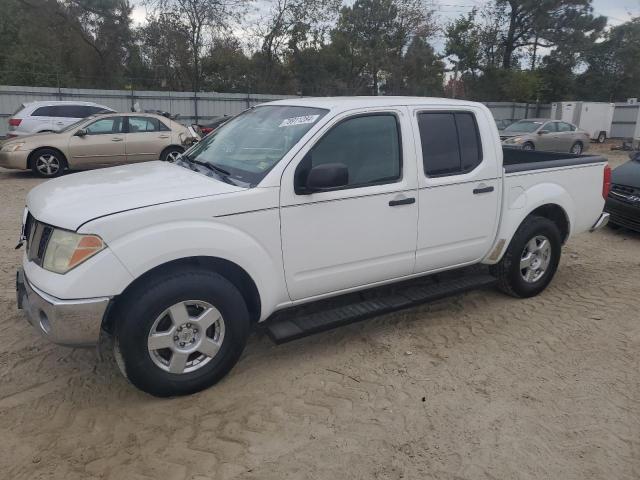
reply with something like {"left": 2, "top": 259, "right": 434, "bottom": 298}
{"left": 17, "top": 97, "right": 610, "bottom": 396}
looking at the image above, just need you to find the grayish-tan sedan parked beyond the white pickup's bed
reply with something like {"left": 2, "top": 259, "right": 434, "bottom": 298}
{"left": 500, "top": 118, "right": 590, "bottom": 155}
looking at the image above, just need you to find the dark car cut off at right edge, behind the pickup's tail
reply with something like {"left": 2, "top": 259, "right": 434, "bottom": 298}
{"left": 605, "top": 152, "right": 640, "bottom": 232}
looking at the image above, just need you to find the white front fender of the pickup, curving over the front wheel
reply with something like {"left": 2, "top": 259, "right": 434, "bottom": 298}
{"left": 102, "top": 218, "right": 289, "bottom": 319}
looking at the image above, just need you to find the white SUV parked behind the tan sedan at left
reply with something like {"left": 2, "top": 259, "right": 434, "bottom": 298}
{"left": 7, "top": 102, "right": 113, "bottom": 138}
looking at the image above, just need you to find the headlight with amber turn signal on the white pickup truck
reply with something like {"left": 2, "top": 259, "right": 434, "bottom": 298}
{"left": 42, "top": 228, "right": 105, "bottom": 273}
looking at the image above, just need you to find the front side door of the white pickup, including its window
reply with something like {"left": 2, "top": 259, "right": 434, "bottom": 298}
{"left": 280, "top": 107, "right": 418, "bottom": 300}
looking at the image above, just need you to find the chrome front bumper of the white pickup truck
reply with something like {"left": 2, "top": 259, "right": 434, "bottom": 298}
{"left": 16, "top": 269, "right": 111, "bottom": 347}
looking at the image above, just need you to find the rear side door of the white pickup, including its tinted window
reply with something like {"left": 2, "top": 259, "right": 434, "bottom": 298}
{"left": 412, "top": 107, "right": 502, "bottom": 272}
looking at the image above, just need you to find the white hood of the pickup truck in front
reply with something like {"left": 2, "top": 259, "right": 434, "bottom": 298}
{"left": 27, "top": 161, "right": 243, "bottom": 230}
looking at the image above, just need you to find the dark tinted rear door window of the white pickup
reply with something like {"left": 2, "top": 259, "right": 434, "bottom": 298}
{"left": 418, "top": 112, "right": 482, "bottom": 177}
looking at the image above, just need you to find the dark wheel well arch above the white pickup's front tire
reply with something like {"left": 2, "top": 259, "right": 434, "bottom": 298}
{"left": 102, "top": 257, "right": 261, "bottom": 333}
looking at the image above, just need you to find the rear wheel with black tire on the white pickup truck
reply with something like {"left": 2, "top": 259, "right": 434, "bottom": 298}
{"left": 491, "top": 215, "right": 562, "bottom": 298}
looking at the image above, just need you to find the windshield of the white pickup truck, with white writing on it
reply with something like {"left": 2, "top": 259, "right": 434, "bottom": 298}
{"left": 185, "top": 105, "right": 328, "bottom": 186}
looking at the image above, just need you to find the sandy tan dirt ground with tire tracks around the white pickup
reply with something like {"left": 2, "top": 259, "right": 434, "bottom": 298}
{"left": 0, "top": 143, "right": 640, "bottom": 480}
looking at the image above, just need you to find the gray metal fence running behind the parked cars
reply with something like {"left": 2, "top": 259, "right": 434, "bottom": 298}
{"left": 0, "top": 86, "right": 640, "bottom": 138}
